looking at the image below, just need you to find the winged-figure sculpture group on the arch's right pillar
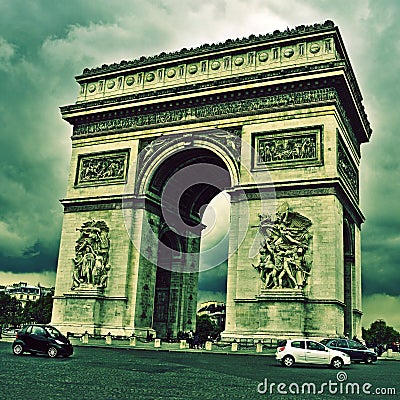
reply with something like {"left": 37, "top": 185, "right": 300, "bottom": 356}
{"left": 253, "top": 202, "right": 312, "bottom": 289}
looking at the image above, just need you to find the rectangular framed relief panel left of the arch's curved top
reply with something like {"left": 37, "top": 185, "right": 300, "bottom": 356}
{"left": 75, "top": 149, "right": 129, "bottom": 186}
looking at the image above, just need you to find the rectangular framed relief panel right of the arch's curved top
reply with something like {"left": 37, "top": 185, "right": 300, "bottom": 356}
{"left": 253, "top": 127, "right": 322, "bottom": 169}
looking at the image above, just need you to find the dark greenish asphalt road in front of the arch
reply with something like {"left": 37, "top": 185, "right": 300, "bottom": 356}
{"left": 0, "top": 342, "right": 400, "bottom": 400}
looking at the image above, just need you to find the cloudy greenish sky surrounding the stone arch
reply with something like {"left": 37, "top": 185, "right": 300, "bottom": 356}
{"left": 0, "top": 0, "right": 400, "bottom": 330}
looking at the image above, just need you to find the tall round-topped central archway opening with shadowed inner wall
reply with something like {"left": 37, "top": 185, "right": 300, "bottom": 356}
{"left": 146, "top": 148, "right": 231, "bottom": 339}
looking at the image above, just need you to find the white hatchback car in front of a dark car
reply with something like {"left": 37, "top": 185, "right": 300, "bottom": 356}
{"left": 275, "top": 339, "right": 351, "bottom": 369}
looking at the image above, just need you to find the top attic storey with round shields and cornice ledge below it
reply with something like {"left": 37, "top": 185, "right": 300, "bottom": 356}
{"left": 61, "top": 21, "right": 372, "bottom": 142}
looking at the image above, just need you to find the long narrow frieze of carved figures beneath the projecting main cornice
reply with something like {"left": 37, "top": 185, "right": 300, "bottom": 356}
{"left": 74, "top": 88, "right": 338, "bottom": 136}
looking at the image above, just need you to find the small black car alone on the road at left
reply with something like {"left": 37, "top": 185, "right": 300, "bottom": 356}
{"left": 12, "top": 324, "right": 73, "bottom": 358}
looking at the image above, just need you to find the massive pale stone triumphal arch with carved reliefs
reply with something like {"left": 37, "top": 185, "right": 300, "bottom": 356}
{"left": 52, "top": 21, "right": 371, "bottom": 339}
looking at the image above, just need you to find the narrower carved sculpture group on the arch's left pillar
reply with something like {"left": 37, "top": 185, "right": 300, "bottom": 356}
{"left": 71, "top": 220, "right": 111, "bottom": 290}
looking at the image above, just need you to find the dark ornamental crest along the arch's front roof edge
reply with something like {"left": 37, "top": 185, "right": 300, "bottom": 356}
{"left": 76, "top": 20, "right": 335, "bottom": 79}
